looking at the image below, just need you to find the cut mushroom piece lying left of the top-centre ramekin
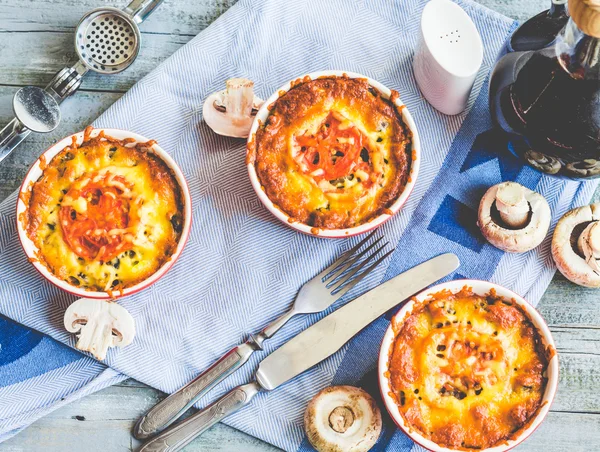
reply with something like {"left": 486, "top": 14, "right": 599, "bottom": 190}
{"left": 202, "top": 78, "right": 263, "bottom": 138}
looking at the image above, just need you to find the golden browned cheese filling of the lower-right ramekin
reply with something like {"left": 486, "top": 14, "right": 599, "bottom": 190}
{"left": 389, "top": 287, "right": 549, "bottom": 450}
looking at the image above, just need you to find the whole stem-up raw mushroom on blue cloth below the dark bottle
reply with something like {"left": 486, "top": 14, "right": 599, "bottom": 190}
{"left": 477, "top": 182, "right": 551, "bottom": 253}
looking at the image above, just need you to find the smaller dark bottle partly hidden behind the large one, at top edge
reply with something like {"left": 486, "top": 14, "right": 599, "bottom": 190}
{"left": 510, "top": 0, "right": 569, "bottom": 52}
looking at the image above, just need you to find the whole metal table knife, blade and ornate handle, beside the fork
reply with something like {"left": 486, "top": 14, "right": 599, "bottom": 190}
{"left": 139, "top": 253, "right": 460, "bottom": 452}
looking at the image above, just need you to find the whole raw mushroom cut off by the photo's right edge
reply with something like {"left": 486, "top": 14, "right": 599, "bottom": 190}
{"left": 552, "top": 204, "right": 600, "bottom": 287}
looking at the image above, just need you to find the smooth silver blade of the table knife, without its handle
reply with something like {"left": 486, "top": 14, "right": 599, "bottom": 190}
{"left": 256, "top": 253, "right": 460, "bottom": 390}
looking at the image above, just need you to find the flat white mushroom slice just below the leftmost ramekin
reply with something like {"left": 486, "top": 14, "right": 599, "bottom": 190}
{"left": 64, "top": 298, "right": 135, "bottom": 360}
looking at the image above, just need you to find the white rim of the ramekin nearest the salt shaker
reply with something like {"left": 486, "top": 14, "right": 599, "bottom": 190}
{"left": 247, "top": 70, "right": 422, "bottom": 238}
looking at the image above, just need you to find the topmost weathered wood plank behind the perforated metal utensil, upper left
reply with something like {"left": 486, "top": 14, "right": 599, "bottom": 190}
{"left": 0, "top": 0, "right": 237, "bottom": 36}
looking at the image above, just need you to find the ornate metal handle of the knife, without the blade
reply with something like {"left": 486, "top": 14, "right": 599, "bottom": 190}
{"left": 139, "top": 381, "right": 262, "bottom": 452}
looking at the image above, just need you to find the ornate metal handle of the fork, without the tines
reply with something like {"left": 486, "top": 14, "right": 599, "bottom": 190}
{"left": 133, "top": 341, "right": 255, "bottom": 439}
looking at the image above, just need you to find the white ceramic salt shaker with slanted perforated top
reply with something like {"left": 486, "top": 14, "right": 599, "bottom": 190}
{"left": 413, "top": 0, "right": 483, "bottom": 115}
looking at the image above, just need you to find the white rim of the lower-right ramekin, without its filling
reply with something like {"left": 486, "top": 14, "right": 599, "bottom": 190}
{"left": 378, "top": 279, "right": 559, "bottom": 452}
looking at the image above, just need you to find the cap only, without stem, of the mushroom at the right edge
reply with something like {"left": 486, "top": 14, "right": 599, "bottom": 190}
{"left": 552, "top": 203, "right": 600, "bottom": 287}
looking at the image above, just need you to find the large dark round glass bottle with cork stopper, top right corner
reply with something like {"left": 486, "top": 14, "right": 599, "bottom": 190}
{"left": 490, "top": 0, "right": 600, "bottom": 179}
